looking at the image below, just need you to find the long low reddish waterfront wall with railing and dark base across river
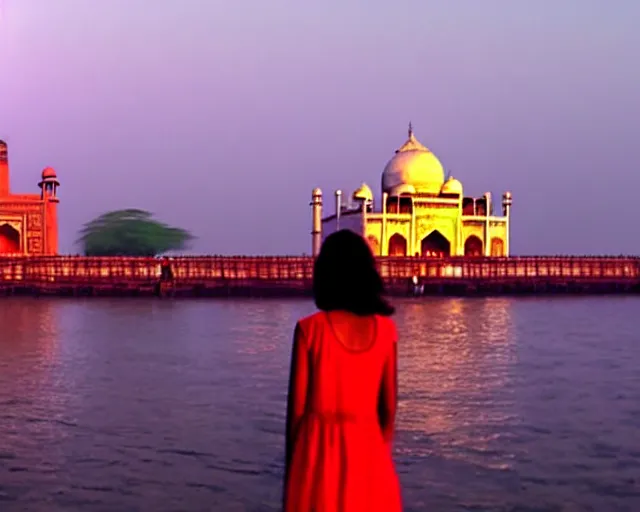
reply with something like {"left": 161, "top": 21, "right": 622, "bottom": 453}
{"left": 0, "top": 256, "right": 640, "bottom": 296}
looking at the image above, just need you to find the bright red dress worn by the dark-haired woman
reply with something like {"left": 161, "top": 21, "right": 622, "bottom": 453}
{"left": 284, "top": 312, "right": 402, "bottom": 512}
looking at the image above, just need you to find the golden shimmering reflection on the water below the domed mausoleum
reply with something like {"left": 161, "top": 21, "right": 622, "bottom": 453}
{"left": 399, "top": 299, "right": 516, "bottom": 469}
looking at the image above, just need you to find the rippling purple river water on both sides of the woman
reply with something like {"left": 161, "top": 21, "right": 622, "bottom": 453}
{"left": 0, "top": 297, "right": 640, "bottom": 512}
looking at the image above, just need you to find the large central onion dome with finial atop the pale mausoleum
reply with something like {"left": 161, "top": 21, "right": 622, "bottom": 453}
{"left": 382, "top": 125, "right": 444, "bottom": 195}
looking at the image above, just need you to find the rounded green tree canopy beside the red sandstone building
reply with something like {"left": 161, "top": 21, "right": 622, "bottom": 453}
{"left": 77, "top": 209, "right": 194, "bottom": 256}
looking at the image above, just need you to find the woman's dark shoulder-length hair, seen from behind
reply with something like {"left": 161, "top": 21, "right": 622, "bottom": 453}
{"left": 313, "top": 229, "right": 395, "bottom": 316}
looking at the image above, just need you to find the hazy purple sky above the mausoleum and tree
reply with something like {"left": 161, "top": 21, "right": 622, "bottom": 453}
{"left": 0, "top": 0, "right": 640, "bottom": 254}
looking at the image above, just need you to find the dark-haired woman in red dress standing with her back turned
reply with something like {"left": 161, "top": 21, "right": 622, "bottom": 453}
{"left": 284, "top": 230, "right": 402, "bottom": 512}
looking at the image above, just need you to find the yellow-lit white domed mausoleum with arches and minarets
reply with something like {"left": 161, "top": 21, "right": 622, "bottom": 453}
{"left": 311, "top": 124, "right": 512, "bottom": 258}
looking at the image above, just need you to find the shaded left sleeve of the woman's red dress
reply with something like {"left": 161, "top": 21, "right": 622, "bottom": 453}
{"left": 285, "top": 323, "right": 310, "bottom": 481}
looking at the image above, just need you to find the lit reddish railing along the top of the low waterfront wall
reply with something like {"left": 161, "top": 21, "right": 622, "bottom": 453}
{"left": 0, "top": 256, "right": 640, "bottom": 285}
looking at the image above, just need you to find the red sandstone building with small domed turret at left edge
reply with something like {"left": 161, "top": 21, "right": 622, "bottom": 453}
{"left": 0, "top": 140, "right": 60, "bottom": 256}
